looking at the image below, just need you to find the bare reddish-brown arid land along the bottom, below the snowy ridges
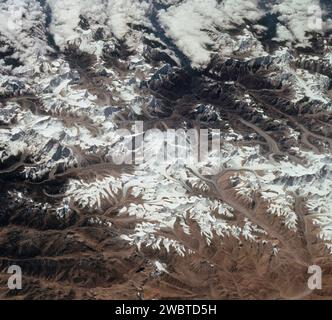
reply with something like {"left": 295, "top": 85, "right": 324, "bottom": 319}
{"left": 0, "top": 188, "right": 332, "bottom": 299}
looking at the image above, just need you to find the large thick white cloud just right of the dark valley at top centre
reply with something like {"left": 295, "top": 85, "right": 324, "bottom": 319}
{"left": 159, "top": 0, "right": 262, "bottom": 65}
